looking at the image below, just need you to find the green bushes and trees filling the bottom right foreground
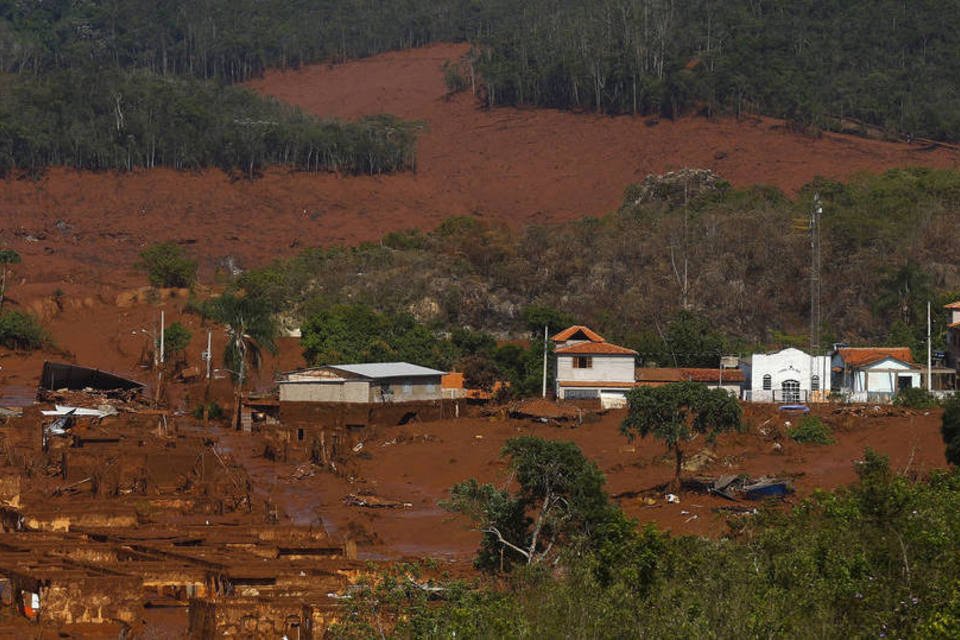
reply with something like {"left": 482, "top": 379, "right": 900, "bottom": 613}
{"left": 329, "top": 445, "right": 960, "bottom": 640}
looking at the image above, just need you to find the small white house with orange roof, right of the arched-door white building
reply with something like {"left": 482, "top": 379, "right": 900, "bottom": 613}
{"left": 833, "top": 347, "right": 921, "bottom": 402}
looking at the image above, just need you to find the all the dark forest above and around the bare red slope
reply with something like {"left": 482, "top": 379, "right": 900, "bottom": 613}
{"left": 0, "top": 0, "right": 960, "bottom": 175}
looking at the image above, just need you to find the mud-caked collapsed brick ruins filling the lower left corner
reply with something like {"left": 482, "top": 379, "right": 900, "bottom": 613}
{"left": 0, "top": 407, "right": 376, "bottom": 640}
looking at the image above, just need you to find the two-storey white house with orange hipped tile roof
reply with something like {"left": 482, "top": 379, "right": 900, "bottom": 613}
{"left": 553, "top": 325, "right": 637, "bottom": 406}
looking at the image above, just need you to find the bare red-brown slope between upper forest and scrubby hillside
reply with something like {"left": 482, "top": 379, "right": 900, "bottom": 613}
{"left": 0, "top": 45, "right": 960, "bottom": 298}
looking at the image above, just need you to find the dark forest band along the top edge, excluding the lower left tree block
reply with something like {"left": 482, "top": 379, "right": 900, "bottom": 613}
{"left": 0, "top": 0, "right": 960, "bottom": 140}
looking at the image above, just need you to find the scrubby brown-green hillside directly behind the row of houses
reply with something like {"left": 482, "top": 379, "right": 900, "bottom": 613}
{"left": 231, "top": 169, "right": 960, "bottom": 366}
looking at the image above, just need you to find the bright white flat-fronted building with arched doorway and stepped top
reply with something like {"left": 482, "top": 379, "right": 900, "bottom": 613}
{"left": 742, "top": 347, "right": 830, "bottom": 404}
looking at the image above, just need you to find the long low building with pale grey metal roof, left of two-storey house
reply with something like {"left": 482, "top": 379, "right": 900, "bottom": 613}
{"left": 277, "top": 362, "right": 444, "bottom": 404}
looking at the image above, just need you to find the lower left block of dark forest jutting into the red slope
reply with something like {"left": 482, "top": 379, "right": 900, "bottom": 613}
{"left": 0, "top": 70, "right": 418, "bottom": 177}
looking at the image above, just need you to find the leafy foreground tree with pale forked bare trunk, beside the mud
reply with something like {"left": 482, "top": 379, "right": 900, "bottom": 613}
{"left": 441, "top": 436, "right": 619, "bottom": 569}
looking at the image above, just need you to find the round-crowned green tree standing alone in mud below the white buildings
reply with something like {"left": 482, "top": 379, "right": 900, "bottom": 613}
{"left": 620, "top": 382, "right": 743, "bottom": 489}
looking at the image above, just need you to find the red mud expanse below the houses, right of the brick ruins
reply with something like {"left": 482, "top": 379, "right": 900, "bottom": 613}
{"left": 222, "top": 407, "right": 946, "bottom": 561}
